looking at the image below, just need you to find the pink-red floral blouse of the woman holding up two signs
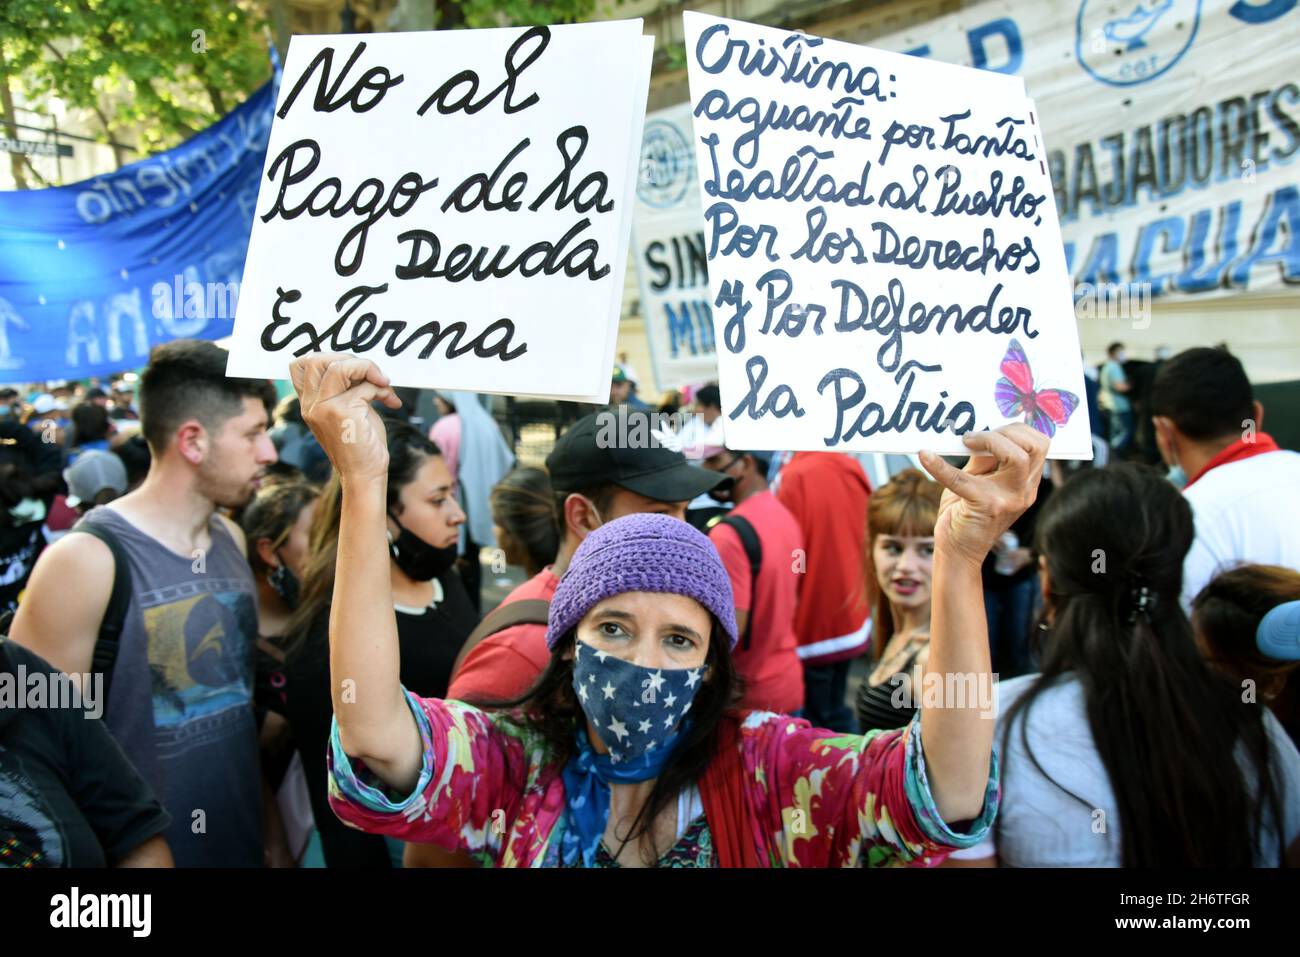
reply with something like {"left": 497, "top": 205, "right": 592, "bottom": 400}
{"left": 328, "top": 692, "right": 998, "bottom": 867}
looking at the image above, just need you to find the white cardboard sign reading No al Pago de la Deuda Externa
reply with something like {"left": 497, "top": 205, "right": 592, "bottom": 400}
{"left": 226, "top": 20, "right": 654, "bottom": 402}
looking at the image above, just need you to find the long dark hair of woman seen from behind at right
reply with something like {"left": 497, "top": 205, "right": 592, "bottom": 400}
{"left": 1001, "top": 464, "right": 1284, "bottom": 867}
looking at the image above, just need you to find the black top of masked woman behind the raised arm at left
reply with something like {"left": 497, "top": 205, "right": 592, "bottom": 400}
{"left": 279, "top": 571, "right": 478, "bottom": 867}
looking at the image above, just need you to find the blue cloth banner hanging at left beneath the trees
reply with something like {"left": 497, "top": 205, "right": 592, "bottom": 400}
{"left": 0, "top": 74, "right": 277, "bottom": 382}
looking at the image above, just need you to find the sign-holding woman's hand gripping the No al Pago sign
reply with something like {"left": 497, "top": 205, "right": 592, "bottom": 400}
{"left": 289, "top": 354, "right": 402, "bottom": 481}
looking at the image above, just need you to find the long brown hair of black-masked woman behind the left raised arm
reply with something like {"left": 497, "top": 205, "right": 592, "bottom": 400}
{"left": 285, "top": 416, "right": 442, "bottom": 654}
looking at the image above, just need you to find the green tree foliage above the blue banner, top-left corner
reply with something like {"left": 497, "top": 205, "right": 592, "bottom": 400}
{"left": 0, "top": 0, "right": 270, "bottom": 161}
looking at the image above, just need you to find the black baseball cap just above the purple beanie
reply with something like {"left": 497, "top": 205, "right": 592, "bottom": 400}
{"left": 546, "top": 408, "right": 735, "bottom": 502}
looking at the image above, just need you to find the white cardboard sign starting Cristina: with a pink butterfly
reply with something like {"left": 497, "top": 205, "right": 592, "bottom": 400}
{"left": 684, "top": 13, "right": 1092, "bottom": 459}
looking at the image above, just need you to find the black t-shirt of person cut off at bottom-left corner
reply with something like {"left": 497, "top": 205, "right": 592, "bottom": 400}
{"left": 0, "top": 638, "right": 172, "bottom": 867}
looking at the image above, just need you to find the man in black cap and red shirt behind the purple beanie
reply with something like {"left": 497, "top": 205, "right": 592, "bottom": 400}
{"left": 447, "top": 410, "right": 733, "bottom": 702}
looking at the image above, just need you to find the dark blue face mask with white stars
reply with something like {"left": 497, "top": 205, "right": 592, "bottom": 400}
{"left": 573, "top": 640, "right": 705, "bottom": 776}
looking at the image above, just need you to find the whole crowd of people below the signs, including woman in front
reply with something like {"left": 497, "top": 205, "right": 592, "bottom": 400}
{"left": 0, "top": 341, "right": 1300, "bottom": 867}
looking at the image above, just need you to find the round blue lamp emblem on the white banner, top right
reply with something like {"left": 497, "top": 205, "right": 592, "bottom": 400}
{"left": 1074, "top": 0, "right": 1201, "bottom": 86}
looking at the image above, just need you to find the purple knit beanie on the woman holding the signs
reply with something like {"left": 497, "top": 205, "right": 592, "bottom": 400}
{"left": 546, "top": 514, "right": 736, "bottom": 649}
